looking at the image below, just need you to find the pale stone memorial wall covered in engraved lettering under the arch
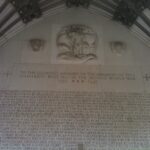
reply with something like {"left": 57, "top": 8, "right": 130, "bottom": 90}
{"left": 0, "top": 9, "right": 150, "bottom": 150}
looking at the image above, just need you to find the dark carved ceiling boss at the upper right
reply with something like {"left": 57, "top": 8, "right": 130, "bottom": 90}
{"left": 114, "top": 0, "right": 150, "bottom": 27}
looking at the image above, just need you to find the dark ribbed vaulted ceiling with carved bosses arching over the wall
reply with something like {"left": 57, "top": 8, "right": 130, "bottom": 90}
{"left": 0, "top": 0, "right": 150, "bottom": 47}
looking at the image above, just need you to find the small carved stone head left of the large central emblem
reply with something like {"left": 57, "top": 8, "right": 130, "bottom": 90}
{"left": 30, "top": 39, "right": 45, "bottom": 52}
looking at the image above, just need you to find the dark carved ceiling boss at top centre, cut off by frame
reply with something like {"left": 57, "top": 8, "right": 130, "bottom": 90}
{"left": 66, "top": 0, "right": 91, "bottom": 7}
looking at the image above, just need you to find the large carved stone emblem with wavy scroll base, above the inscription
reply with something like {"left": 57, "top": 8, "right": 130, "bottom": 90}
{"left": 56, "top": 24, "right": 98, "bottom": 62}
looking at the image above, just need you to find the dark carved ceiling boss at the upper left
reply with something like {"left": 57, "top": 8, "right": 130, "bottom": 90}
{"left": 10, "top": 0, "right": 41, "bottom": 23}
